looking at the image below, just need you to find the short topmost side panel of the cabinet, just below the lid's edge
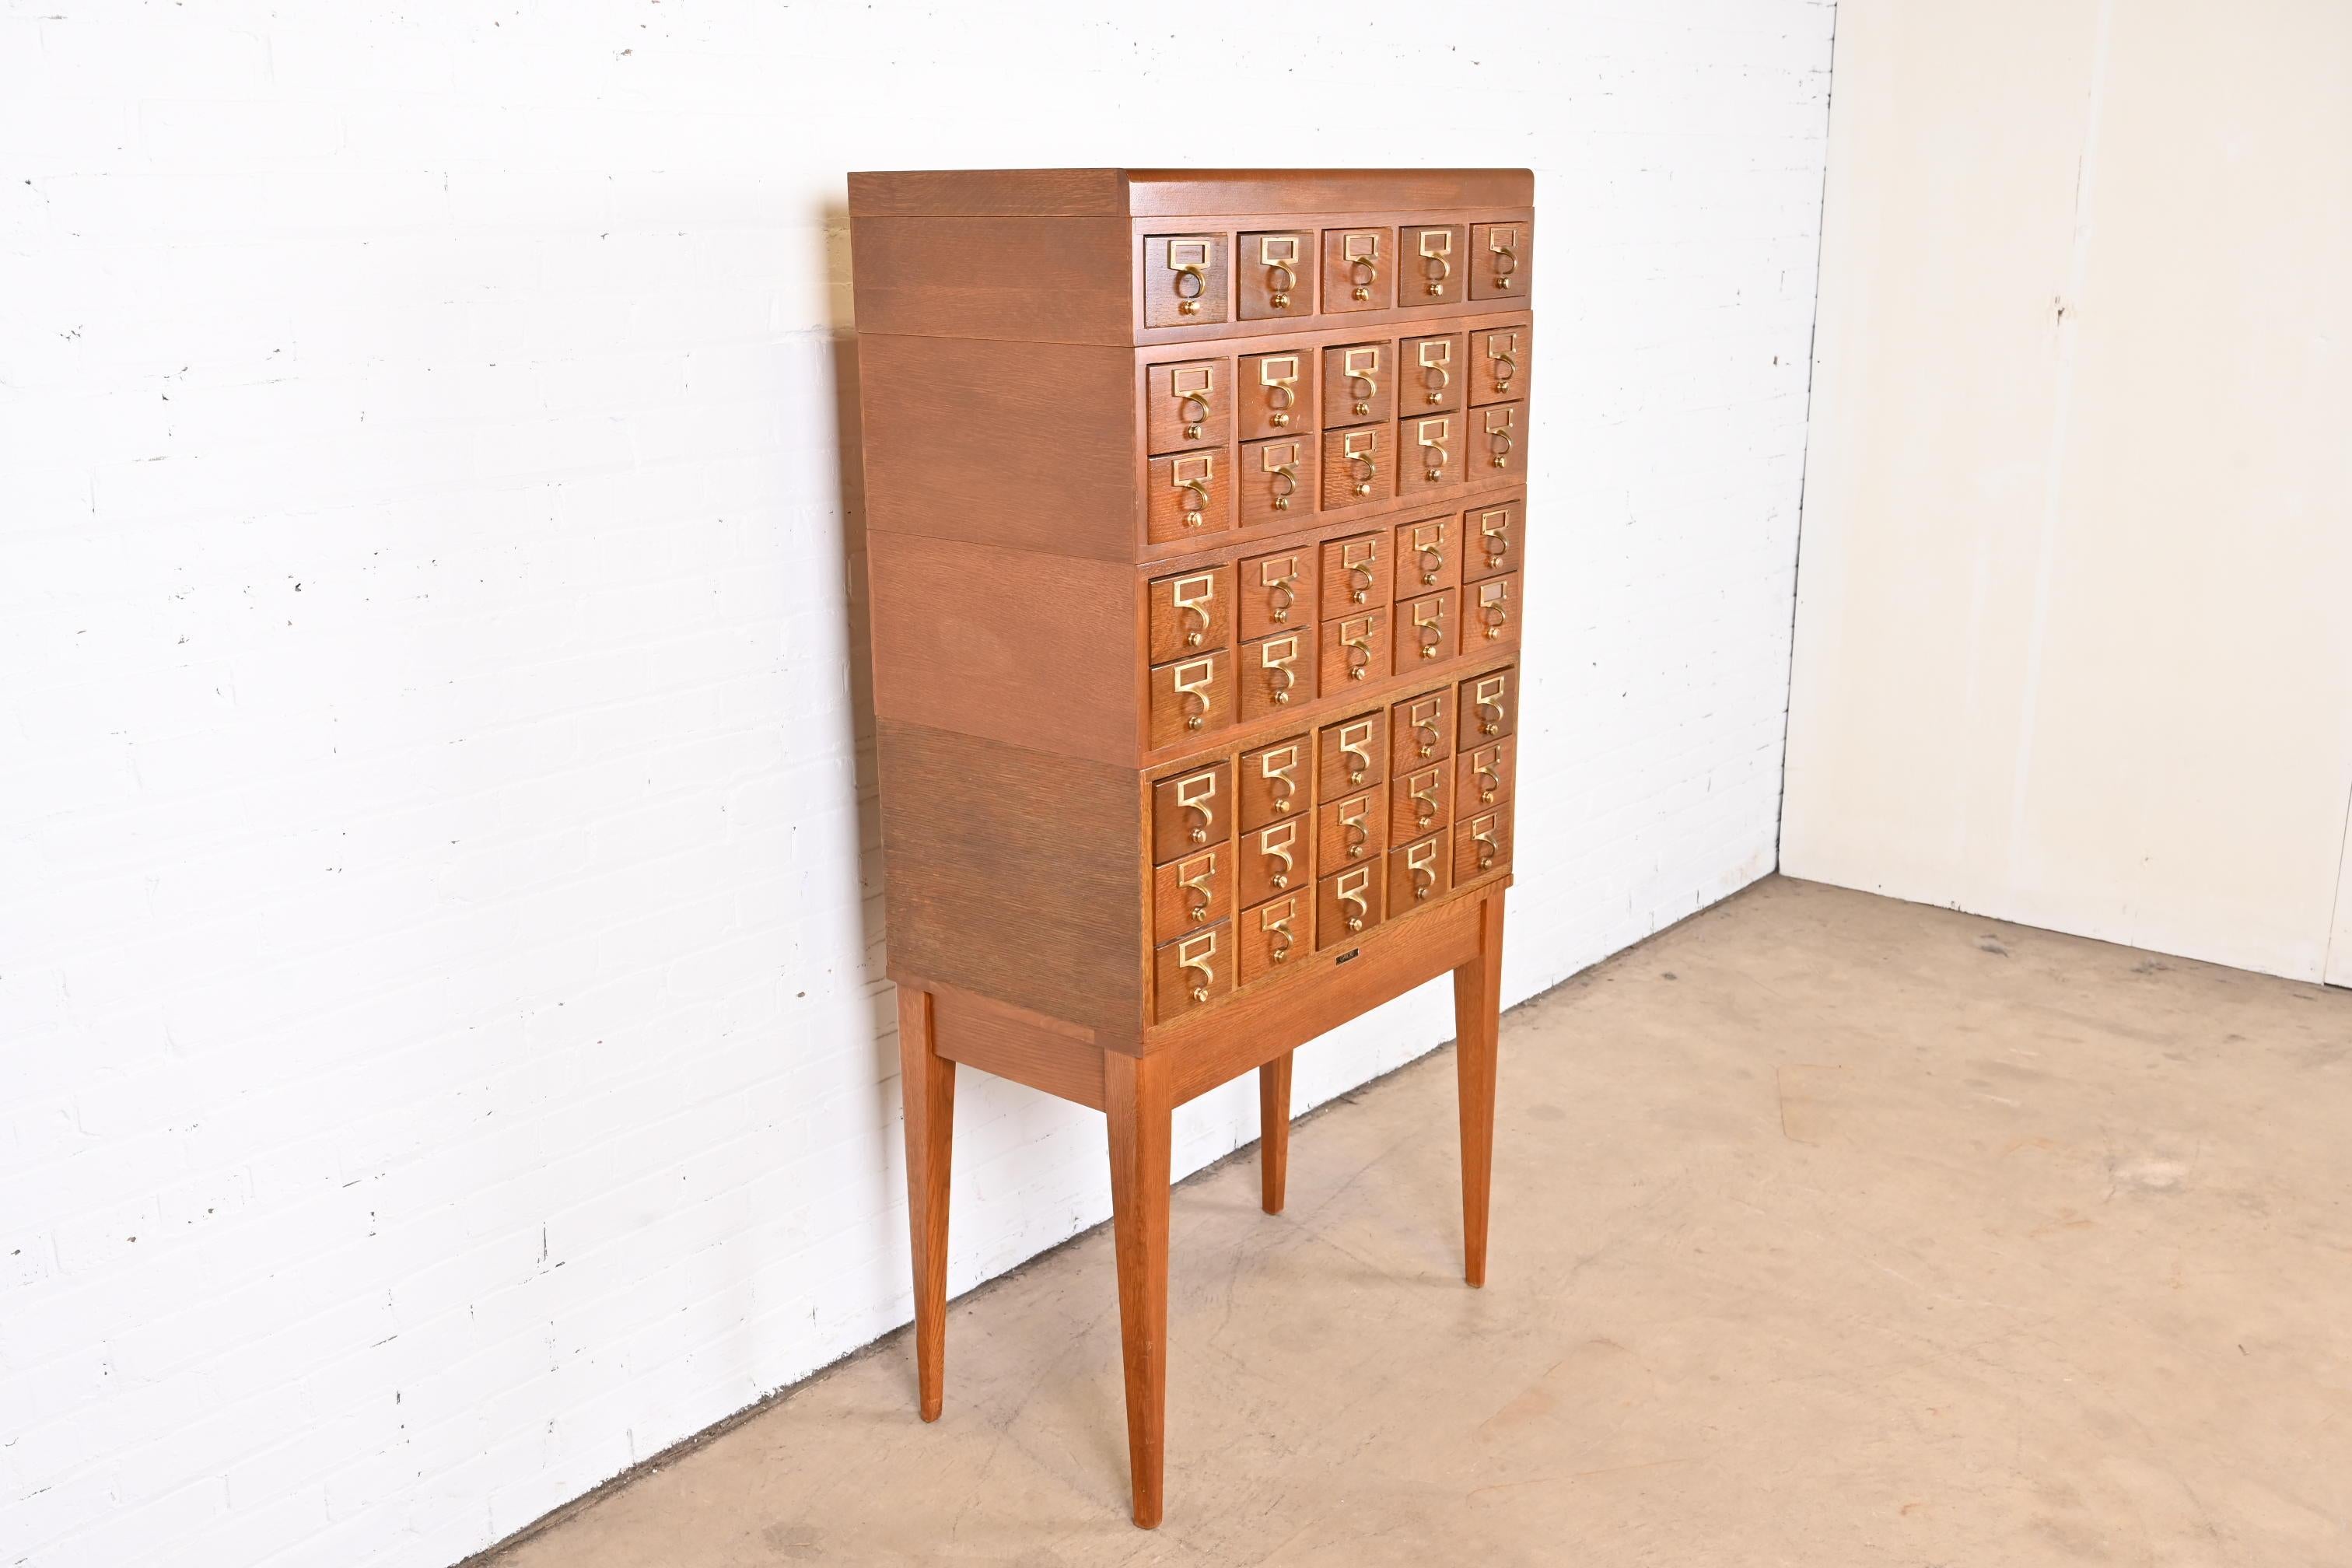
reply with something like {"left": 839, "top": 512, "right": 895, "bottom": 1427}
{"left": 849, "top": 216, "right": 1134, "bottom": 343}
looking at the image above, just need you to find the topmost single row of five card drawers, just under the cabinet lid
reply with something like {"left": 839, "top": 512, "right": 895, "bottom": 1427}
{"left": 1143, "top": 219, "right": 1536, "bottom": 327}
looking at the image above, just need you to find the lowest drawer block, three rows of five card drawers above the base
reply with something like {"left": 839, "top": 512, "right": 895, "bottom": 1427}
{"left": 1153, "top": 667, "right": 1517, "bottom": 1023}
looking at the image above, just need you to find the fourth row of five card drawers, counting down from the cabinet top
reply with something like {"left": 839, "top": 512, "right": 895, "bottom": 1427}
{"left": 1146, "top": 496, "right": 1527, "bottom": 665}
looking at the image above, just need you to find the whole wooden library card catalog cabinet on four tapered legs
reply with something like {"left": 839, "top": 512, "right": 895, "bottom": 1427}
{"left": 849, "top": 170, "right": 1536, "bottom": 1526}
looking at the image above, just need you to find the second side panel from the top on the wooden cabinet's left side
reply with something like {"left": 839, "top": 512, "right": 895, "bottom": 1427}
{"left": 859, "top": 331, "right": 1143, "bottom": 562}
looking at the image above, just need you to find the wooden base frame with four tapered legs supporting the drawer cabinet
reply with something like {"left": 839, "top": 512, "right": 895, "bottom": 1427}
{"left": 898, "top": 893, "right": 1507, "bottom": 1531}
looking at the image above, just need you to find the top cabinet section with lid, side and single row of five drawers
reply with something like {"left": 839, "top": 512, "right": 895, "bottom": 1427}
{"left": 849, "top": 170, "right": 1536, "bottom": 345}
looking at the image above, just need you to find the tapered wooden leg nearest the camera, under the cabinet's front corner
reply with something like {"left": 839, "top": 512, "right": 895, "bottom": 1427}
{"left": 1103, "top": 1051, "right": 1176, "bottom": 1531}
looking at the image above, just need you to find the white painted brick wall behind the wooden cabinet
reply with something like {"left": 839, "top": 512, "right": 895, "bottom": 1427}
{"left": 0, "top": 0, "right": 1832, "bottom": 1568}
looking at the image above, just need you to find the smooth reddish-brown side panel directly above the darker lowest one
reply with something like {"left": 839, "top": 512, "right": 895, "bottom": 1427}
{"left": 866, "top": 534, "right": 1143, "bottom": 766}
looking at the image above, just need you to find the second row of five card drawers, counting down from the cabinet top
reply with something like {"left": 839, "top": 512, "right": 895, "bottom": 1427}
{"left": 1143, "top": 322, "right": 1531, "bottom": 456}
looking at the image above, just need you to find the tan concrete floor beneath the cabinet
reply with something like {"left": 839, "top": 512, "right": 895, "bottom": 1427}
{"left": 496, "top": 879, "right": 2352, "bottom": 1568}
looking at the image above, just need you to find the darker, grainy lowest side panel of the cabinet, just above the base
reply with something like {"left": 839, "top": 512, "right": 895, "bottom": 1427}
{"left": 877, "top": 719, "right": 1143, "bottom": 1044}
